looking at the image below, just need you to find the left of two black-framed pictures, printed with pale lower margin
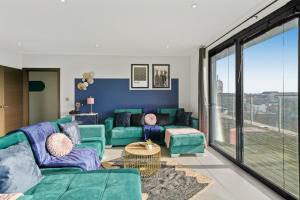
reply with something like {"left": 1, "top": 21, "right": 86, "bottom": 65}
{"left": 131, "top": 64, "right": 149, "bottom": 88}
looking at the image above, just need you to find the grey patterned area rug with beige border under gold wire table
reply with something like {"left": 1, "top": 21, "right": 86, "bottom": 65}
{"left": 102, "top": 158, "right": 213, "bottom": 200}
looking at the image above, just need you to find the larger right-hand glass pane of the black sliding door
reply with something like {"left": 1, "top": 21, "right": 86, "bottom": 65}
{"left": 242, "top": 19, "right": 299, "bottom": 196}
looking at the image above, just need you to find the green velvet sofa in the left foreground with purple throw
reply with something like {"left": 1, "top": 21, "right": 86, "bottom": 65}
{"left": 0, "top": 118, "right": 142, "bottom": 200}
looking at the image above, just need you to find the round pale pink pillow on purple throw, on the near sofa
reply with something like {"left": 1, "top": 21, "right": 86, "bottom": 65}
{"left": 46, "top": 133, "right": 73, "bottom": 157}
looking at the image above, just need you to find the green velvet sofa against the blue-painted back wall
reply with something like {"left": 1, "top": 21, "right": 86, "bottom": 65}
{"left": 104, "top": 108, "right": 198, "bottom": 147}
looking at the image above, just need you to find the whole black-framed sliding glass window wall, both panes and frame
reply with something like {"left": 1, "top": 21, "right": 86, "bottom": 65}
{"left": 209, "top": 1, "right": 300, "bottom": 199}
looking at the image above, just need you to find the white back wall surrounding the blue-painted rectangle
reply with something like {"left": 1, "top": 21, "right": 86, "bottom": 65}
{"left": 23, "top": 54, "right": 191, "bottom": 115}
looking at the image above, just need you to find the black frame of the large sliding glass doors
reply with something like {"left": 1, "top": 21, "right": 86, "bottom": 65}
{"left": 208, "top": 0, "right": 300, "bottom": 199}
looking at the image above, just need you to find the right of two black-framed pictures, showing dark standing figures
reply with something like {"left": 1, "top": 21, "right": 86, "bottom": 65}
{"left": 152, "top": 64, "right": 170, "bottom": 88}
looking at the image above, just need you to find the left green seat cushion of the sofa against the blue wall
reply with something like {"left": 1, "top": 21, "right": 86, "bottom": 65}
{"left": 111, "top": 126, "right": 143, "bottom": 138}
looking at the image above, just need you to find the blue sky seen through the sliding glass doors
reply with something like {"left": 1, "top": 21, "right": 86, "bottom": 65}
{"left": 216, "top": 20, "right": 298, "bottom": 94}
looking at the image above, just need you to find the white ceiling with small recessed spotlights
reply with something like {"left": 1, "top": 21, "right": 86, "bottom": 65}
{"left": 0, "top": 0, "right": 280, "bottom": 55}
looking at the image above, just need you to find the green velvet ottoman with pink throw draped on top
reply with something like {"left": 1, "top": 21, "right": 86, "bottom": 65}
{"left": 165, "top": 128, "right": 206, "bottom": 157}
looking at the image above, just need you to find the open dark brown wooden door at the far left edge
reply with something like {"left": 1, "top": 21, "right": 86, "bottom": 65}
{"left": 0, "top": 67, "right": 23, "bottom": 135}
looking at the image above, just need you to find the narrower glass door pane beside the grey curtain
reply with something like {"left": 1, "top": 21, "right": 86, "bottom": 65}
{"left": 211, "top": 46, "right": 236, "bottom": 157}
